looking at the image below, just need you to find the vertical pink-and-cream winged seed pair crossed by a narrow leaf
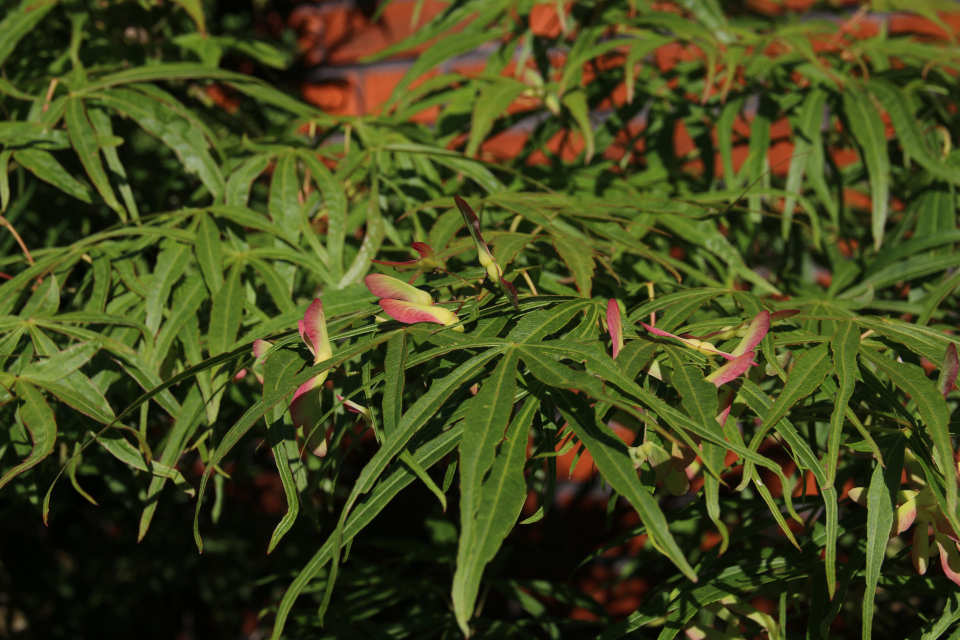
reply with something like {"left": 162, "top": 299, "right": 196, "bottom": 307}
{"left": 290, "top": 298, "right": 333, "bottom": 458}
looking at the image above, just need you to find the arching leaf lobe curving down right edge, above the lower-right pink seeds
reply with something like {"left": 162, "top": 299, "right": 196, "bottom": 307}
{"left": 860, "top": 349, "right": 960, "bottom": 530}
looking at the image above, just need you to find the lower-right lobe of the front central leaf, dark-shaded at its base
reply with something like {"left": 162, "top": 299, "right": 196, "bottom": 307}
{"left": 548, "top": 388, "right": 697, "bottom": 582}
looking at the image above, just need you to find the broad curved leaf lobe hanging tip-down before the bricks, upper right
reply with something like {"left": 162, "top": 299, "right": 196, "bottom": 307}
{"left": 843, "top": 84, "right": 890, "bottom": 250}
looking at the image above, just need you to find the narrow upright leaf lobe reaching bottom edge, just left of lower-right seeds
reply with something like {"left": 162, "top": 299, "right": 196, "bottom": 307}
{"left": 861, "top": 438, "right": 904, "bottom": 640}
